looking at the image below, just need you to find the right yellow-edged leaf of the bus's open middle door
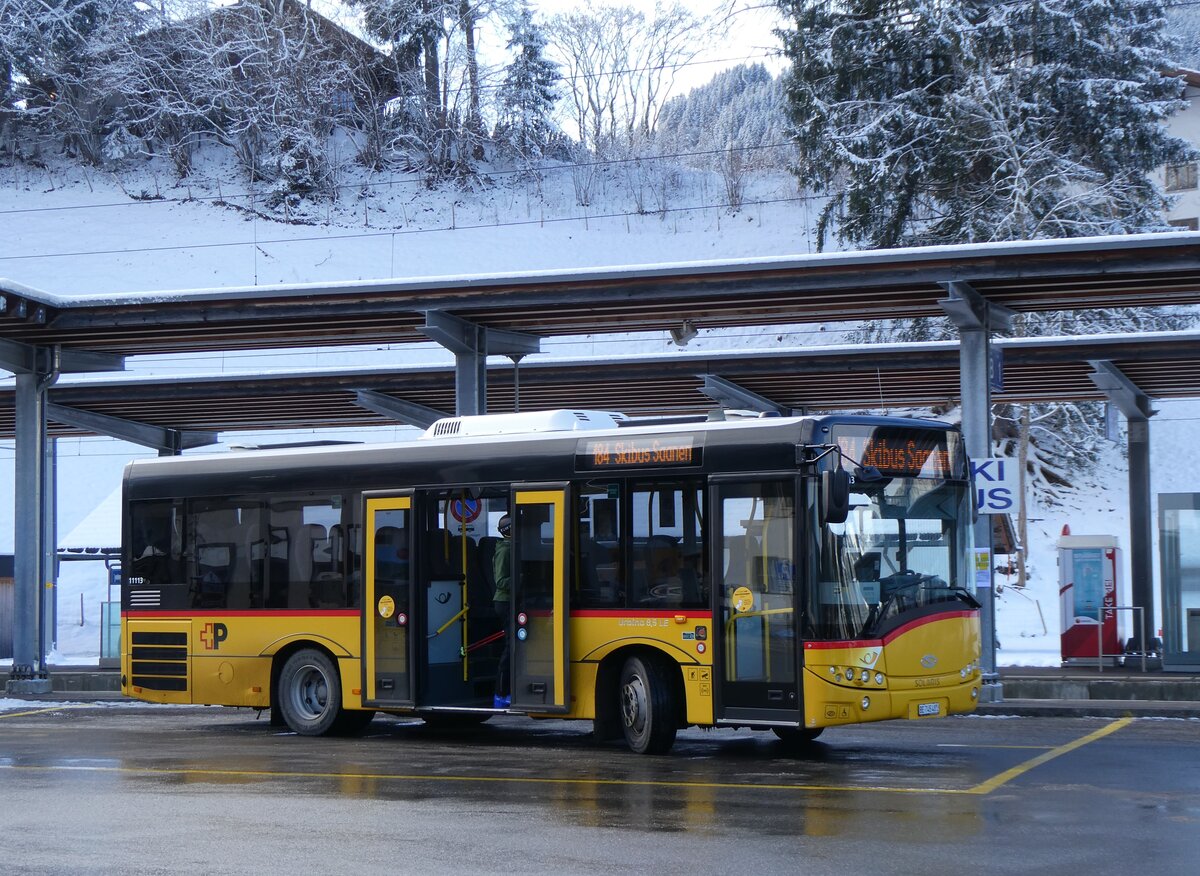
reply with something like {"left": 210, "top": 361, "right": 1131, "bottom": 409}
{"left": 508, "top": 484, "right": 570, "bottom": 713}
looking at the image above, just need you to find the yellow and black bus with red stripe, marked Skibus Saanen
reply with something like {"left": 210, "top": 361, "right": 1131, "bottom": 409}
{"left": 121, "top": 410, "right": 980, "bottom": 754}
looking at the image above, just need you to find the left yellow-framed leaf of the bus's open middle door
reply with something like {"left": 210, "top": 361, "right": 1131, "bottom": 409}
{"left": 362, "top": 493, "right": 414, "bottom": 708}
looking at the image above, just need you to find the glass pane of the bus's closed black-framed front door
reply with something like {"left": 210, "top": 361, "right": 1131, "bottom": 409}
{"left": 720, "top": 481, "right": 797, "bottom": 686}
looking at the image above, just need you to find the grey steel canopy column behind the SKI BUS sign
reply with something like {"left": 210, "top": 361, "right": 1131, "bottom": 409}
{"left": 940, "top": 283, "right": 1008, "bottom": 702}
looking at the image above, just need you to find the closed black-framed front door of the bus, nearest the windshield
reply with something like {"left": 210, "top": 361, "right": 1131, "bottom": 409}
{"left": 712, "top": 478, "right": 803, "bottom": 726}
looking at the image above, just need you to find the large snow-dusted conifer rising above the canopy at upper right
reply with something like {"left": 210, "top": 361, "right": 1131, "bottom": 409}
{"left": 779, "top": 0, "right": 1190, "bottom": 247}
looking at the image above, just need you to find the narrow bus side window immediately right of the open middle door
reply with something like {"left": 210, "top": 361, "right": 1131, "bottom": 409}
{"left": 571, "top": 484, "right": 625, "bottom": 608}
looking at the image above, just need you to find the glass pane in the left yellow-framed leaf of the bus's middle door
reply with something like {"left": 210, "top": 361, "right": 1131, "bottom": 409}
{"left": 372, "top": 509, "right": 413, "bottom": 700}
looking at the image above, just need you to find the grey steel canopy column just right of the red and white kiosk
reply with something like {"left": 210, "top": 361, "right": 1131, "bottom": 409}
{"left": 1088, "top": 360, "right": 1158, "bottom": 650}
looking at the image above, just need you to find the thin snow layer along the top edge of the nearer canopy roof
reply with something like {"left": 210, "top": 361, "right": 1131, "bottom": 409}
{"left": 7, "top": 232, "right": 1200, "bottom": 308}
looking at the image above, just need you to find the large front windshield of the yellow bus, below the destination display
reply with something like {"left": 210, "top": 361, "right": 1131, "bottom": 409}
{"left": 809, "top": 478, "right": 979, "bottom": 640}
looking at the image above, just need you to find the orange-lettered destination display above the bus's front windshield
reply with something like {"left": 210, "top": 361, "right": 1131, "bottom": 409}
{"left": 834, "top": 427, "right": 964, "bottom": 478}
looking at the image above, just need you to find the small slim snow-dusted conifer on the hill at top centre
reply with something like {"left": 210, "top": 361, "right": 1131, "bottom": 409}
{"left": 496, "top": 5, "right": 559, "bottom": 162}
